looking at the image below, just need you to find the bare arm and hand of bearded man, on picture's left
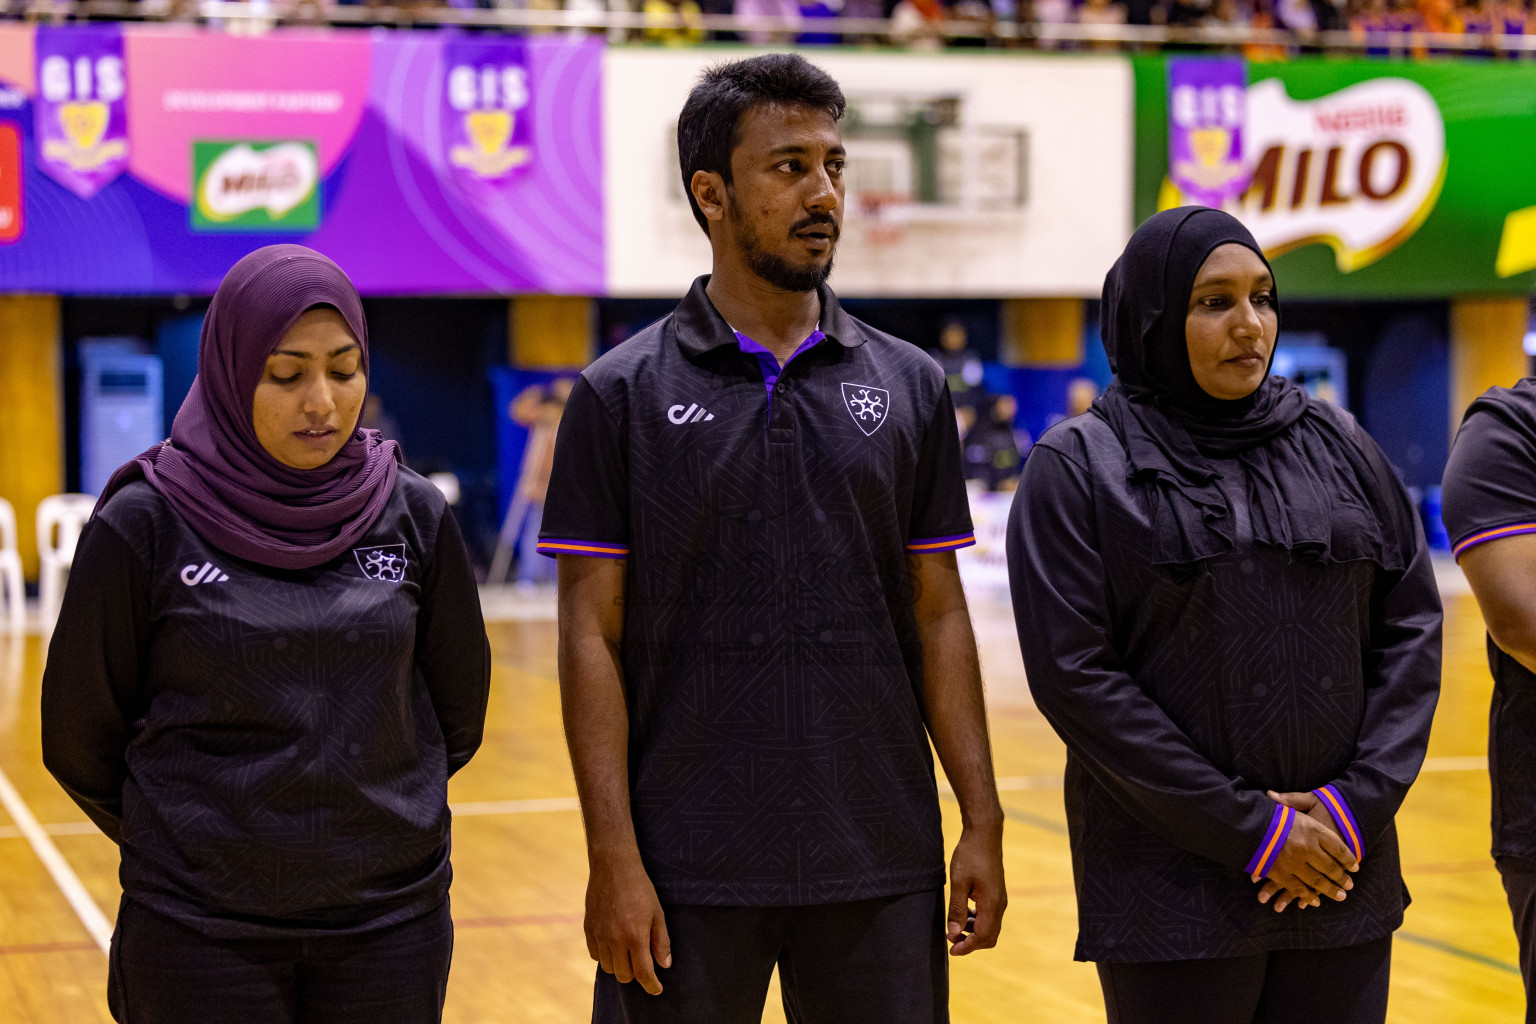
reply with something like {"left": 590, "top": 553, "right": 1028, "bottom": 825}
{"left": 559, "top": 554, "right": 671, "bottom": 995}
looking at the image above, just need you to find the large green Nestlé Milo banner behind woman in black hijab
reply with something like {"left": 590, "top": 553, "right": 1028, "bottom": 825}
{"left": 1134, "top": 57, "right": 1536, "bottom": 298}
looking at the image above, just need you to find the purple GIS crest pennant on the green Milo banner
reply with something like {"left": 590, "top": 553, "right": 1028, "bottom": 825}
{"left": 1167, "top": 58, "right": 1249, "bottom": 207}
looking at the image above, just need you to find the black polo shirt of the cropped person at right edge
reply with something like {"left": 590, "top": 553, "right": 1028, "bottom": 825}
{"left": 1442, "top": 379, "right": 1536, "bottom": 870}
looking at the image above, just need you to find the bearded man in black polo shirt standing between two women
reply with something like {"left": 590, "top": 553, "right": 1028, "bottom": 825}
{"left": 539, "top": 54, "right": 1006, "bottom": 1024}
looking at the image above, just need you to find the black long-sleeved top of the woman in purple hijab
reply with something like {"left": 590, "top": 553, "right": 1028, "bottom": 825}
{"left": 43, "top": 470, "right": 490, "bottom": 938}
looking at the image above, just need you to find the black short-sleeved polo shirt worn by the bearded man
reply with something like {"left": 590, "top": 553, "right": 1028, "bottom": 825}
{"left": 539, "top": 278, "right": 972, "bottom": 906}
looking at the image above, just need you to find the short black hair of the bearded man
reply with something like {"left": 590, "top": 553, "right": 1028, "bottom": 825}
{"left": 677, "top": 54, "right": 848, "bottom": 235}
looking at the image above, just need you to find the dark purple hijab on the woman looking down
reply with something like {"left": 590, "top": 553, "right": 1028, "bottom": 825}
{"left": 97, "top": 246, "right": 399, "bottom": 570}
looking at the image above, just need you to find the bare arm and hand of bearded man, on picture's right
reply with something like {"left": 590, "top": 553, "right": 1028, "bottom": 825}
{"left": 909, "top": 551, "right": 1008, "bottom": 956}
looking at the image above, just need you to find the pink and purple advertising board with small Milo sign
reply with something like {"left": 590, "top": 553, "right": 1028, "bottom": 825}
{"left": 0, "top": 23, "right": 604, "bottom": 295}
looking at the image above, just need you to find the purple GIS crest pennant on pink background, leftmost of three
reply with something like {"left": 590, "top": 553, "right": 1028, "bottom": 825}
{"left": 34, "top": 25, "right": 127, "bottom": 200}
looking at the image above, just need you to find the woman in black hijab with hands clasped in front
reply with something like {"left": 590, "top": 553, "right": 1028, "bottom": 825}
{"left": 1008, "top": 207, "right": 1441, "bottom": 1024}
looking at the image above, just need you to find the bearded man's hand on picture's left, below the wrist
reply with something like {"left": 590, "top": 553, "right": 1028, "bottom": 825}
{"left": 584, "top": 852, "right": 671, "bottom": 995}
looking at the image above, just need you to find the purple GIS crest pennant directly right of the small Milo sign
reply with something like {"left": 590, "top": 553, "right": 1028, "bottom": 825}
{"left": 441, "top": 37, "right": 533, "bottom": 186}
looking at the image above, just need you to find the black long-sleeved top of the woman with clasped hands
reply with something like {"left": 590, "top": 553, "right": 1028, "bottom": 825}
{"left": 1008, "top": 411, "right": 1441, "bottom": 963}
